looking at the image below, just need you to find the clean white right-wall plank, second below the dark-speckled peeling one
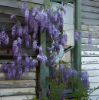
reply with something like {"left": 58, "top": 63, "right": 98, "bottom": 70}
{"left": 81, "top": 64, "right": 99, "bottom": 70}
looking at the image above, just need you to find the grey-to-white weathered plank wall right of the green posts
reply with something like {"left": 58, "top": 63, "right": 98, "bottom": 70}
{"left": 81, "top": 0, "right": 99, "bottom": 100}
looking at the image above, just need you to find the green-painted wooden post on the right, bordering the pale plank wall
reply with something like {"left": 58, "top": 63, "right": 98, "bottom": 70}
{"left": 71, "top": 0, "right": 81, "bottom": 71}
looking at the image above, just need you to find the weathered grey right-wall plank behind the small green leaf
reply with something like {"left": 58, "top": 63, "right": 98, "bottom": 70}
{"left": 81, "top": 25, "right": 99, "bottom": 33}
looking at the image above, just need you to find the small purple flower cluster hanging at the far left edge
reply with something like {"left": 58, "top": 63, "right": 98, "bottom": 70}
{"left": 0, "top": 26, "right": 9, "bottom": 47}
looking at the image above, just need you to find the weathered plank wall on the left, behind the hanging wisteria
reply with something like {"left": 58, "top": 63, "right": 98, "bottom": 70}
{"left": 0, "top": 0, "right": 44, "bottom": 100}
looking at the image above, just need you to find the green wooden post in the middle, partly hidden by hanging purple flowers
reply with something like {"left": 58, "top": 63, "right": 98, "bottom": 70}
{"left": 39, "top": 0, "right": 50, "bottom": 97}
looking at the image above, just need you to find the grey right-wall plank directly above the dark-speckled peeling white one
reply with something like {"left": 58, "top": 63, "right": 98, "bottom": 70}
{"left": 81, "top": 44, "right": 99, "bottom": 51}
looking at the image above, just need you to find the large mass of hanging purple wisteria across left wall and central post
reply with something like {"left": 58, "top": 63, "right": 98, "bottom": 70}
{"left": 1, "top": 3, "right": 67, "bottom": 79}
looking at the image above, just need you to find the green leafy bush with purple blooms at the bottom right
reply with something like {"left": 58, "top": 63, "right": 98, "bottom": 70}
{"left": 26, "top": 67, "right": 99, "bottom": 100}
